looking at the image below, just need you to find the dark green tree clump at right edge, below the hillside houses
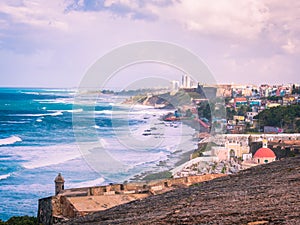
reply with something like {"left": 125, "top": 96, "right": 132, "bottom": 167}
{"left": 254, "top": 105, "right": 300, "bottom": 133}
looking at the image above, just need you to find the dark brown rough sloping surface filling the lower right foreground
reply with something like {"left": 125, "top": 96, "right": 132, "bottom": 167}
{"left": 62, "top": 157, "right": 300, "bottom": 225}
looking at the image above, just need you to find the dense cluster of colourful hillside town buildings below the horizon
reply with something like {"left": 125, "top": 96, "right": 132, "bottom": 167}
{"left": 171, "top": 77, "right": 300, "bottom": 134}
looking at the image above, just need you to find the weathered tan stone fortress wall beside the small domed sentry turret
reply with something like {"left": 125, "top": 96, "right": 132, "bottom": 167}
{"left": 38, "top": 174, "right": 225, "bottom": 225}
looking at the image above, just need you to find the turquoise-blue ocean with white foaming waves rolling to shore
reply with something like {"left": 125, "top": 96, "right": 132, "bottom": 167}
{"left": 0, "top": 88, "right": 196, "bottom": 220}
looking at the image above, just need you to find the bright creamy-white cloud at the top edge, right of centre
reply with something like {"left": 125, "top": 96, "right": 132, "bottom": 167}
{"left": 157, "top": 0, "right": 269, "bottom": 39}
